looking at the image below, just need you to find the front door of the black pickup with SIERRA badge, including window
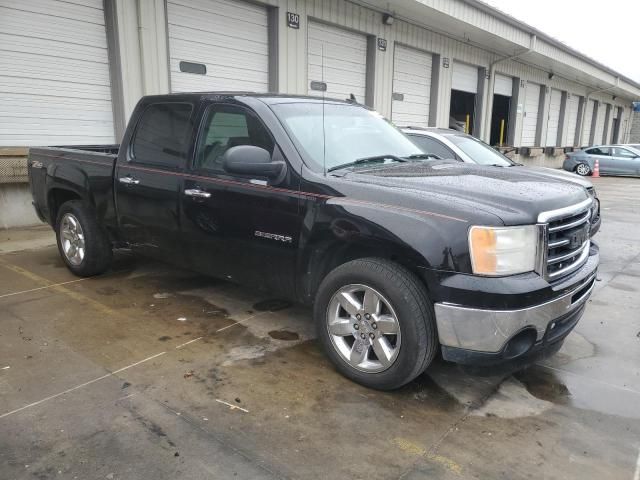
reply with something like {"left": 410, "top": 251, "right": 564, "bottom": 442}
{"left": 181, "top": 104, "right": 302, "bottom": 295}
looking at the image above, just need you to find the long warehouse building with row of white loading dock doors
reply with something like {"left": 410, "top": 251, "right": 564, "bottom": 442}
{"left": 0, "top": 0, "right": 640, "bottom": 227}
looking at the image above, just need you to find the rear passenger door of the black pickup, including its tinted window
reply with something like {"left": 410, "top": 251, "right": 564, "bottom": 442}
{"left": 114, "top": 101, "right": 194, "bottom": 261}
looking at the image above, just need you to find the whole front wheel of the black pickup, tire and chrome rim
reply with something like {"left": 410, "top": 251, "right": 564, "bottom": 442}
{"left": 314, "top": 258, "right": 438, "bottom": 390}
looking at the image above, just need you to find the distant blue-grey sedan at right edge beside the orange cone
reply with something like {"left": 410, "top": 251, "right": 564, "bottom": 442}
{"left": 562, "top": 145, "right": 640, "bottom": 176}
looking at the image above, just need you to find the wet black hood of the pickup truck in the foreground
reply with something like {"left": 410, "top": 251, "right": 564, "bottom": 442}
{"left": 343, "top": 160, "right": 588, "bottom": 225}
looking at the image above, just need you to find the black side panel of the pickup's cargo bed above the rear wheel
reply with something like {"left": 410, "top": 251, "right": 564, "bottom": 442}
{"left": 28, "top": 145, "right": 120, "bottom": 227}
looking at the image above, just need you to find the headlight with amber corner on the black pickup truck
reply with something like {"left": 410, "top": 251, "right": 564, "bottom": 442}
{"left": 469, "top": 225, "right": 538, "bottom": 277}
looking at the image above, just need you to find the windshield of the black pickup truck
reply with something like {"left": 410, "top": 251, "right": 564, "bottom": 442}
{"left": 272, "top": 102, "right": 423, "bottom": 172}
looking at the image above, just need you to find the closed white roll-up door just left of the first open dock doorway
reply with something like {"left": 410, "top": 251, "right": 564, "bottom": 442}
{"left": 391, "top": 44, "right": 433, "bottom": 127}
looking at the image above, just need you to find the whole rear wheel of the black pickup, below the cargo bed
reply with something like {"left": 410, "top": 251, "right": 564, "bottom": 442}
{"left": 55, "top": 200, "right": 113, "bottom": 277}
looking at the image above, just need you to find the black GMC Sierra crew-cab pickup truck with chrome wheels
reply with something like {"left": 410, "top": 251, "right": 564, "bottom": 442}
{"left": 29, "top": 93, "right": 599, "bottom": 389}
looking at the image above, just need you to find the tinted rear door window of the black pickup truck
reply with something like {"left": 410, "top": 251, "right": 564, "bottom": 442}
{"left": 131, "top": 103, "right": 193, "bottom": 168}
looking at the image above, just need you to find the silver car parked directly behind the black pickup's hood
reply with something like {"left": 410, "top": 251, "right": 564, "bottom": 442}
{"left": 402, "top": 127, "right": 602, "bottom": 236}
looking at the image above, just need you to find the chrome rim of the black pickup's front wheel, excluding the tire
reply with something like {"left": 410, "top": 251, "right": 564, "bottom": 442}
{"left": 327, "top": 285, "right": 401, "bottom": 373}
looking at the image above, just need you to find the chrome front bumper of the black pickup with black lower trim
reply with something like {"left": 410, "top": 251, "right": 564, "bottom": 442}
{"left": 435, "top": 244, "right": 599, "bottom": 363}
